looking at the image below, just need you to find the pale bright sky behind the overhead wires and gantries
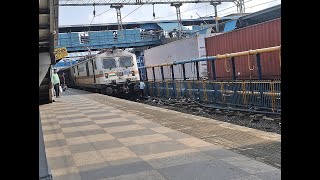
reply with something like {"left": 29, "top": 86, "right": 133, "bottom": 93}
{"left": 59, "top": 0, "right": 281, "bottom": 26}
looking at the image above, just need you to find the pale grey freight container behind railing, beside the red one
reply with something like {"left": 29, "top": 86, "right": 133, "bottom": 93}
{"left": 144, "top": 33, "right": 221, "bottom": 80}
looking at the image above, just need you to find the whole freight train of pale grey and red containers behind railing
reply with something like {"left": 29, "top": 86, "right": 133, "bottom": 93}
{"left": 144, "top": 18, "right": 281, "bottom": 81}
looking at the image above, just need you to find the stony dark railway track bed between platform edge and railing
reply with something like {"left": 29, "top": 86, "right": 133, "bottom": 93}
{"left": 72, "top": 88, "right": 281, "bottom": 134}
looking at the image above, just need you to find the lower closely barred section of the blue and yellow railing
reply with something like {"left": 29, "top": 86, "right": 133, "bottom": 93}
{"left": 146, "top": 80, "right": 281, "bottom": 112}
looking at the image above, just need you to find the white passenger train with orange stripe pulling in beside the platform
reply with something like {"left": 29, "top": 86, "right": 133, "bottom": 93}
{"left": 59, "top": 49, "right": 140, "bottom": 95}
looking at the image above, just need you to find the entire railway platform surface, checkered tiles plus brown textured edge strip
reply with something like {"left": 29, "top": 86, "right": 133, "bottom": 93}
{"left": 40, "top": 89, "right": 281, "bottom": 180}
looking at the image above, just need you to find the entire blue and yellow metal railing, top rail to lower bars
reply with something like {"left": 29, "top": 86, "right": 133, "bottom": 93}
{"left": 139, "top": 46, "right": 281, "bottom": 112}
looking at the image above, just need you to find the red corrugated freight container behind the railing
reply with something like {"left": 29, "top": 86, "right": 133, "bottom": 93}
{"left": 205, "top": 18, "right": 281, "bottom": 80}
